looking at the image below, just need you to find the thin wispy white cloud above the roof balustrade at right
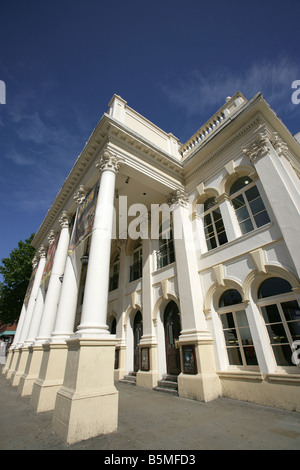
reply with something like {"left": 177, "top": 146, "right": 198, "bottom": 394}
{"left": 163, "top": 57, "right": 300, "bottom": 118}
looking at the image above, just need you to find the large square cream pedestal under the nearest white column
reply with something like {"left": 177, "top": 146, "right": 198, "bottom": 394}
{"left": 52, "top": 338, "right": 118, "bottom": 444}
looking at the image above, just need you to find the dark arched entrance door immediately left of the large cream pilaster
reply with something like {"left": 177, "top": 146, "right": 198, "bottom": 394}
{"left": 164, "top": 301, "right": 181, "bottom": 375}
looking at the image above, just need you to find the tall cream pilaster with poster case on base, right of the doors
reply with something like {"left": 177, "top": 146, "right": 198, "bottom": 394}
{"left": 168, "top": 191, "right": 221, "bottom": 401}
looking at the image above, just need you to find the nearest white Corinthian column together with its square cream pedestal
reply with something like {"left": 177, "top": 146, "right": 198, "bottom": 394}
{"left": 53, "top": 150, "right": 120, "bottom": 444}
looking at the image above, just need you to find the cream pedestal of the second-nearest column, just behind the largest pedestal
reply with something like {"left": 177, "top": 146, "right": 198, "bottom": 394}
{"left": 30, "top": 343, "right": 68, "bottom": 413}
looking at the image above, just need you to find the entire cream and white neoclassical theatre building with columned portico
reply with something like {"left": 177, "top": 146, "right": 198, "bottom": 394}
{"left": 4, "top": 92, "right": 300, "bottom": 443}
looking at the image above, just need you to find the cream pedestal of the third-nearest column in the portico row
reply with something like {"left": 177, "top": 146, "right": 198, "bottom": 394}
{"left": 18, "top": 346, "right": 43, "bottom": 397}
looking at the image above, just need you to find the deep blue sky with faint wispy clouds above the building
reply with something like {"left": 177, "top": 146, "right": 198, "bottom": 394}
{"left": 0, "top": 0, "right": 300, "bottom": 272}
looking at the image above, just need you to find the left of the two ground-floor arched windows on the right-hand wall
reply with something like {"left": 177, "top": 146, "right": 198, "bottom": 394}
{"left": 218, "top": 289, "right": 258, "bottom": 366}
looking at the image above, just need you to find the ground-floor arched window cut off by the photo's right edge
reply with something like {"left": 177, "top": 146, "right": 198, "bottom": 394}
{"left": 257, "top": 277, "right": 300, "bottom": 366}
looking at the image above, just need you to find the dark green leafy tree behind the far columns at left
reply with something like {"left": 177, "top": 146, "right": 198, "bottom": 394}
{"left": 0, "top": 233, "right": 35, "bottom": 323}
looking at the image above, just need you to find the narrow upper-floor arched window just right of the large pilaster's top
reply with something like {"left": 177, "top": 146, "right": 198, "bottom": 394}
{"left": 203, "top": 197, "right": 227, "bottom": 250}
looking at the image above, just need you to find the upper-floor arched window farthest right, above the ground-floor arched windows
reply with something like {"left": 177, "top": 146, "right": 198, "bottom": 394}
{"left": 230, "top": 176, "right": 270, "bottom": 234}
